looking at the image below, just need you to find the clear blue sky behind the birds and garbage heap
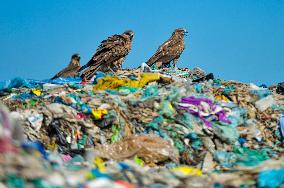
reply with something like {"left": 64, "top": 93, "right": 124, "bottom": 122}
{"left": 0, "top": 0, "right": 284, "bottom": 84}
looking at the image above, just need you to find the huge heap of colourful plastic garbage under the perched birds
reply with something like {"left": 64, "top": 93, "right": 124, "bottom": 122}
{"left": 0, "top": 68, "right": 284, "bottom": 188}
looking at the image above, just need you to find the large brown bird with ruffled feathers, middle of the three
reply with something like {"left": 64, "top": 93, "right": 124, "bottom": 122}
{"left": 80, "top": 30, "right": 134, "bottom": 81}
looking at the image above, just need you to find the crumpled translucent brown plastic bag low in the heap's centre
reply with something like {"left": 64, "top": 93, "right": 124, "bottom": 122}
{"left": 95, "top": 135, "right": 179, "bottom": 163}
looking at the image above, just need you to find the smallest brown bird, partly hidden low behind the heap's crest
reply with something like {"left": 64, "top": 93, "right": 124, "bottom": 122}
{"left": 51, "top": 54, "right": 80, "bottom": 80}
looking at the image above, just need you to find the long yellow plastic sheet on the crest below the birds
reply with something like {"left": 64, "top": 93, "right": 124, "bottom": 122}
{"left": 93, "top": 73, "right": 161, "bottom": 91}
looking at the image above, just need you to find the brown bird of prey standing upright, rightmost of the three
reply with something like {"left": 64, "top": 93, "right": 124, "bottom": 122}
{"left": 146, "top": 28, "right": 187, "bottom": 68}
